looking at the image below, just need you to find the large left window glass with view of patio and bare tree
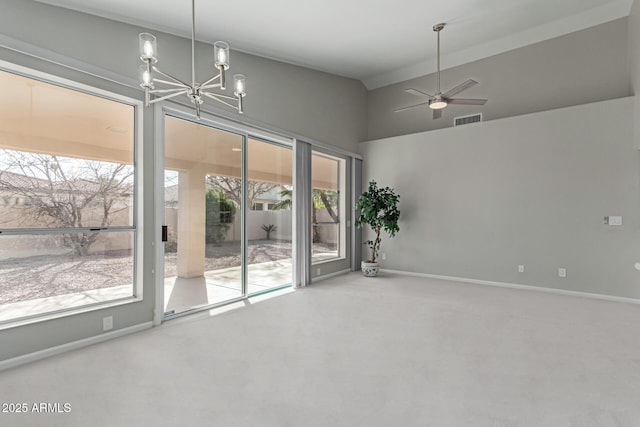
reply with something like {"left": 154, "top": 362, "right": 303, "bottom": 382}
{"left": 0, "top": 67, "right": 137, "bottom": 323}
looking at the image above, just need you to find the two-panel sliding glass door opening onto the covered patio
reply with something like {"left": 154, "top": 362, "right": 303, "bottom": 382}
{"left": 162, "top": 116, "right": 292, "bottom": 317}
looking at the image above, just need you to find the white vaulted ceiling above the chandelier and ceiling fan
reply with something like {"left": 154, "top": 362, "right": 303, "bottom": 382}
{"left": 33, "top": 0, "right": 633, "bottom": 89}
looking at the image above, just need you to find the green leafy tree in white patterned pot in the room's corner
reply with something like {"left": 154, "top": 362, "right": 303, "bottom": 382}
{"left": 355, "top": 180, "right": 400, "bottom": 277}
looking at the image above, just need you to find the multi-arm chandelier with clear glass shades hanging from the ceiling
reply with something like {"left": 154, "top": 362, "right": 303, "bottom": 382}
{"left": 138, "top": 0, "right": 246, "bottom": 119}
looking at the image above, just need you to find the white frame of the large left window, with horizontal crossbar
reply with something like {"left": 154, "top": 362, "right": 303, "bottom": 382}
{"left": 0, "top": 60, "right": 144, "bottom": 330}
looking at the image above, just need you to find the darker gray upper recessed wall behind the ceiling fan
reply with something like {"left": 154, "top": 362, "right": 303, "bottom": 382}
{"left": 367, "top": 18, "right": 637, "bottom": 140}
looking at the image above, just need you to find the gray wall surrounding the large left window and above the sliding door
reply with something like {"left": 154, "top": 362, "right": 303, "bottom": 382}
{"left": 0, "top": 0, "right": 366, "bottom": 360}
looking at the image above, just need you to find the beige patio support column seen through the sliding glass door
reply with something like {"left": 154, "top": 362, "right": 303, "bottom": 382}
{"left": 177, "top": 165, "right": 205, "bottom": 278}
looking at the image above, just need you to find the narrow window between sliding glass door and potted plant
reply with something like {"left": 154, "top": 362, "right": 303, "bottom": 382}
{"left": 311, "top": 151, "right": 346, "bottom": 263}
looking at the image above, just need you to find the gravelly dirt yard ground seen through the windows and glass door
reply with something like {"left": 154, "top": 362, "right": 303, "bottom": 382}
{"left": 0, "top": 240, "right": 335, "bottom": 305}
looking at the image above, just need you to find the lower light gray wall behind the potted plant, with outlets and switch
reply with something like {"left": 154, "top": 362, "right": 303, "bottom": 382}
{"left": 360, "top": 98, "right": 640, "bottom": 298}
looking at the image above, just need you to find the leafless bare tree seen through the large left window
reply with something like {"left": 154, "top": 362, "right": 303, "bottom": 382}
{"left": 0, "top": 150, "right": 133, "bottom": 255}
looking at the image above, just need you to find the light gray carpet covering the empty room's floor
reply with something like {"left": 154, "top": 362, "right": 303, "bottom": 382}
{"left": 0, "top": 273, "right": 640, "bottom": 427}
